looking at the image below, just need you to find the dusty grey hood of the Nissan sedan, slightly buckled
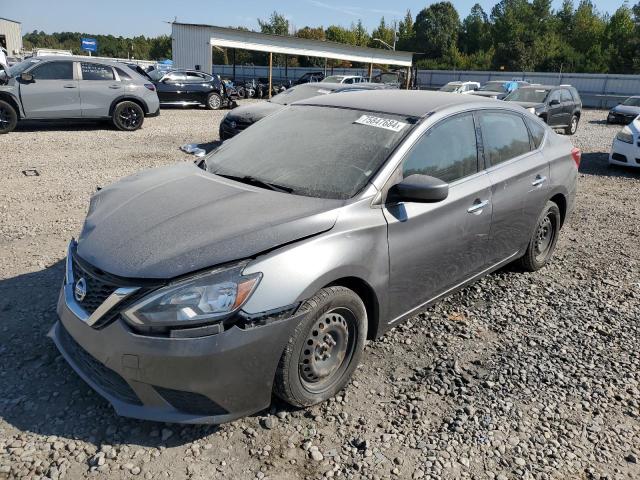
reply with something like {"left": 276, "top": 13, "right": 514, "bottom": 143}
{"left": 77, "top": 163, "right": 344, "bottom": 279}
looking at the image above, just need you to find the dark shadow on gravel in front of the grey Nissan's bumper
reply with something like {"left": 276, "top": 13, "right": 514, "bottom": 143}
{"left": 0, "top": 261, "right": 217, "bottom": 447}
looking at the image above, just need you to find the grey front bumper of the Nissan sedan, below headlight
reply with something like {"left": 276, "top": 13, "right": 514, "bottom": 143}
{"left": 49, "top": 286, "right": 301, "bottom": 424}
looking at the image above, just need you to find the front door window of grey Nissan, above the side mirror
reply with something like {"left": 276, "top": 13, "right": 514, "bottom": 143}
{"left": 402, "top": 114, "right": 478, "bottom": 183}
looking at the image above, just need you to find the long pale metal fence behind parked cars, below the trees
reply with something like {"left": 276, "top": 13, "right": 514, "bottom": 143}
{"left": 213, "top": 65, "right": 640, "bottom": 108}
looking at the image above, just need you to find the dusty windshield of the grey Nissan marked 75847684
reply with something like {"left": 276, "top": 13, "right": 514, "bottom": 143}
{"left": 206, "top": 105, "right": 415, "bottom": 199}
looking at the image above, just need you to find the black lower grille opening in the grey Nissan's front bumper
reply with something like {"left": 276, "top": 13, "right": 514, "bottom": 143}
{"left": 60, "top": 324, "right": 142, "bottom": 405}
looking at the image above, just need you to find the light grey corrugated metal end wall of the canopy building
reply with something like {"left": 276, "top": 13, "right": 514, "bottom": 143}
{"left": 171, "top": 23, "right": 212, "bottom": 72}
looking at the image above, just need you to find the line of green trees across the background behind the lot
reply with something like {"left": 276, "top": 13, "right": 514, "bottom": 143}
{"left": 24, "top": 0, "right": 640, "bottom": 73}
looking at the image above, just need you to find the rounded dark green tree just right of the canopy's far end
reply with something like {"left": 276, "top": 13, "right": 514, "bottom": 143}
{"left": 414, "top": 2, "right": 460, "bottom": 58}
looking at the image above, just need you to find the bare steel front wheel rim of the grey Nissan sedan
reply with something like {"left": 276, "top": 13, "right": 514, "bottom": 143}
{"left": 299, "top": 308, "right": 357, "bottom": 393}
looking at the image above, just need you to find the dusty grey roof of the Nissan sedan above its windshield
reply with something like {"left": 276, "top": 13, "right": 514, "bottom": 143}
{"left": 294, "top": 89, "right": 505, "bottom": 117}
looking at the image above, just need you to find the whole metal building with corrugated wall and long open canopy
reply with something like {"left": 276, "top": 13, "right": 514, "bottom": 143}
{"left": 171, "top": 22, "right": 413, "bottom": 85}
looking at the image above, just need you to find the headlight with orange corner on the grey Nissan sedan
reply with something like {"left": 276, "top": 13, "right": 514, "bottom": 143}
{"left": 123, "top": 262, "right": 262, "bottom": 326}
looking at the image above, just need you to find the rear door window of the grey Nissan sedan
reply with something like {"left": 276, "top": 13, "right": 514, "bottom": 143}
{"left": 479, "top": 112, "right": 531, "bottom": 166}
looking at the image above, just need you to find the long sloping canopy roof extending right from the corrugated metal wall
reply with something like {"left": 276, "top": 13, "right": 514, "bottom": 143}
{"left": 202, "top": 25, "right": 413, "bottom": 67}
